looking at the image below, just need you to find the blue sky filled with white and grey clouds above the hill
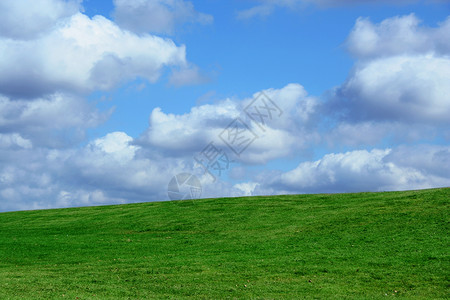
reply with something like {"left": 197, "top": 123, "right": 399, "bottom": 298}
{"left": 0, "top": 0, "right": 450, "bottom": 211}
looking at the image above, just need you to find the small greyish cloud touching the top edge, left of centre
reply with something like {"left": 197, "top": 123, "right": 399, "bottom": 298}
{"left": 113, "top": 0, "right": 213, "bottom": 34}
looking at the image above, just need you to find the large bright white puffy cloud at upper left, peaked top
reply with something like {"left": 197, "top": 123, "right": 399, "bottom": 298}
{"left": 0, "top": 13, "right": 187, "bottom": 98}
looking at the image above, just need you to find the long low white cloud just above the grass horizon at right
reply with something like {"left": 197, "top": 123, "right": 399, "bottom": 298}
{"left": 266, "top": 145, "right": 450, "bottom": 193}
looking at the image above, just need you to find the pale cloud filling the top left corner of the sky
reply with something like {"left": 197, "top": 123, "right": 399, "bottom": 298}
{"left": 0, "top": 0, "right": 81, "bottom": 39}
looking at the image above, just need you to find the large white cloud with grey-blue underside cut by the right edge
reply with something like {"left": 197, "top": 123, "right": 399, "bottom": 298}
{"left": 336, "top": 55, "right": 450, "bottom": 124}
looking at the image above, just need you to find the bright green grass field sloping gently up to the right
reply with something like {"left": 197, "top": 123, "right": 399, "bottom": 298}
{"left": 0, "top": 188, "right": 450, "bottom": 299}
